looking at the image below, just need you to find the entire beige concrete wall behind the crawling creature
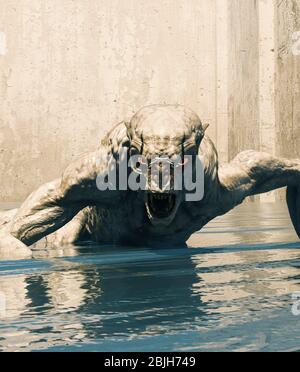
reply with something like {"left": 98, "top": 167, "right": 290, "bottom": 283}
{"left": 0, "top": 0, "right": 300, "bottom": 202}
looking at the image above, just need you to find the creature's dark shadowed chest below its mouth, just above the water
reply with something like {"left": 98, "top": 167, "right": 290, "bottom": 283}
{"left": 88, "top": 199, "right": 207, "bottom": 245}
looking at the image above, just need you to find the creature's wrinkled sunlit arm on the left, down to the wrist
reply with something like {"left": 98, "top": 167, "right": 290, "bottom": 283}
{"left": 10, "top": 150, "right": 113, "bottom": 246}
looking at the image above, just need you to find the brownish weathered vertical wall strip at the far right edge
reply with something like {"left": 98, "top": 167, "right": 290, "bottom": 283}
{"left": 275, "top": 0, "right": 300, "bottom": 158}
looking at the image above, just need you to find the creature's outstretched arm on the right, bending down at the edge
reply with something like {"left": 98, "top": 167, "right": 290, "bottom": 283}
{"left": 219, "top": 151, "right": 300, "bottom": 238}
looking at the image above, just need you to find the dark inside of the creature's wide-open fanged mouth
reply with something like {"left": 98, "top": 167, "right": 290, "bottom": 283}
{"left": 147, "top": 193, "right": 176, "bottom": 218}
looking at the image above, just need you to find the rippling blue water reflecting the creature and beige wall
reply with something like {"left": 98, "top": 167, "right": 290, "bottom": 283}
{"left": 0, "top": 204, "right": 300, "bottom": 351}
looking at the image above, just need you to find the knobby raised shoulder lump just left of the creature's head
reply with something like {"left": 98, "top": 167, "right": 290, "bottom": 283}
{"left": 101, "top": 121, "right": 129, "bottom": 155}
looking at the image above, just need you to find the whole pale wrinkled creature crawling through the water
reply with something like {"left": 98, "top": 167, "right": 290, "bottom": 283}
{"left": 0, "top": 105, "right": 300, "bottom": 256}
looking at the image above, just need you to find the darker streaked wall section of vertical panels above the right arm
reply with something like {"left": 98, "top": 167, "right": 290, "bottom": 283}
{"left": 228, "top": 0, "right": 300, "bottom": 201}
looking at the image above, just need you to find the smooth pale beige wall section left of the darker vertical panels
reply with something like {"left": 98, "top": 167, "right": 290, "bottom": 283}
{"left": 0, "top": 0, "right": 227, "bottom": 201}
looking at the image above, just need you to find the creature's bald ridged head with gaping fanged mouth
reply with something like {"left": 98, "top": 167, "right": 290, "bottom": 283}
{"left": 127, "top": 105, "right": 208, "bottom": 226}
